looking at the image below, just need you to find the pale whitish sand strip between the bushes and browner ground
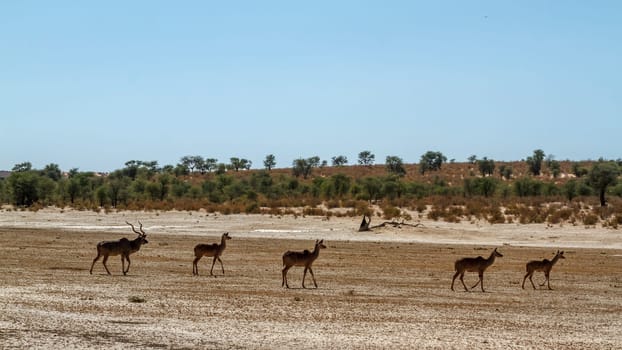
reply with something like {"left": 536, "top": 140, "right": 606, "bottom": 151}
{"left": 0, "top": 208, "right": 622, "bottom": 249}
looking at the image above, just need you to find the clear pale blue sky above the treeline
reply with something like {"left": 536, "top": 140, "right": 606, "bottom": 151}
{"left": 0, "top": 0, "right": 622, "bottom": 171}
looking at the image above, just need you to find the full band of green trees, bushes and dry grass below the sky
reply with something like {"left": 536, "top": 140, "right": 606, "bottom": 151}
{"left": 0, "top": 149, "right": 622, "bottom": 228}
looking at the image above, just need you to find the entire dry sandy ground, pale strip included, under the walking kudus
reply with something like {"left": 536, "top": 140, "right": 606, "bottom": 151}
{"left": 0, "top": 209, "right": 622, "bottom": 349}
